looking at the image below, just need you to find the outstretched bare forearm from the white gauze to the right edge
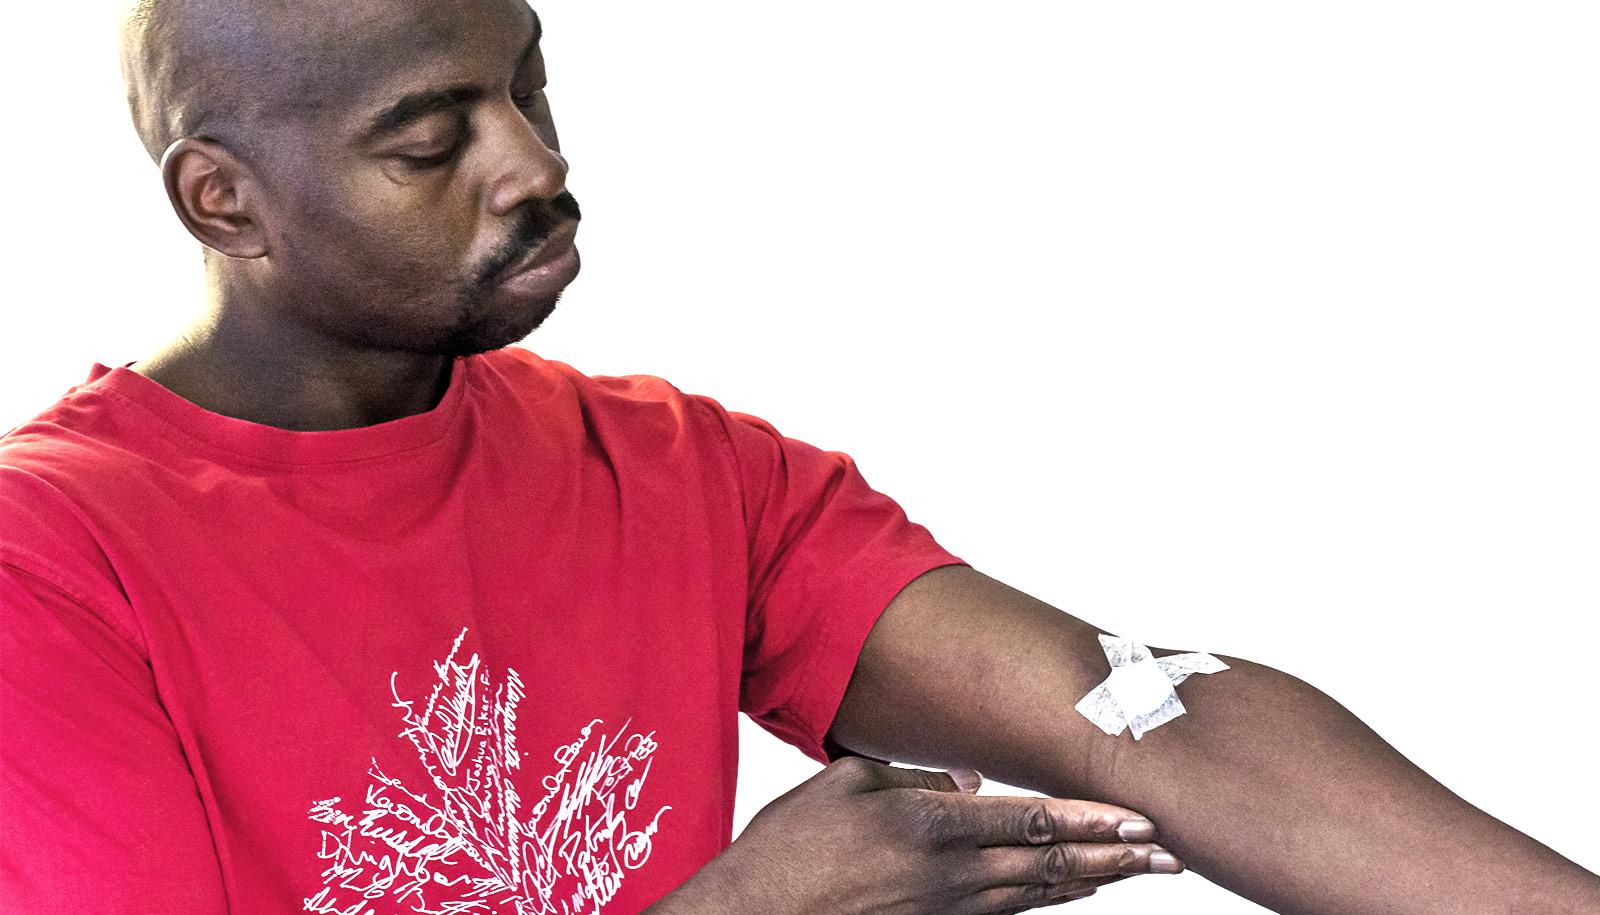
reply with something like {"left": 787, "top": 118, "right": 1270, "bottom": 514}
{"left": 1056, "top": 659, "right": 1600, "bottom": 915}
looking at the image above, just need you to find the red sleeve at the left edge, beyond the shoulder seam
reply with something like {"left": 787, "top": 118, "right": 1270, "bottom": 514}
{"left": 0, "top": 557, "right": 226, "bottom": 915}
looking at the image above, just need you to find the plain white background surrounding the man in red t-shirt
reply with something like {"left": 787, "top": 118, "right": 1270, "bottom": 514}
{"left": 0, "top": 0, "right": 1600, "bottom": 913}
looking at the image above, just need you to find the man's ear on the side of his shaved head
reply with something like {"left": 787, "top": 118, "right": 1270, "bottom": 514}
{"left": 162, "top": 136, "right": 267, "bottom": 258}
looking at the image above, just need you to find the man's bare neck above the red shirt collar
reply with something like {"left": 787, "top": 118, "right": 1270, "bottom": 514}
{"left": 131, "top": 299, "right": 451, "bottom": 432}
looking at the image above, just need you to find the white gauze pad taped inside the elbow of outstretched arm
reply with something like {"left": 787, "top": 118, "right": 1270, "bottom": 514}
{"left": 1075, "top": 635, "right": 1227, "bottom": 741}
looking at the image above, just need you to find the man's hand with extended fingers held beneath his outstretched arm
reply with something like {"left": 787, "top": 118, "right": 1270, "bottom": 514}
{"left": 648, "top": 757, "right": 1182, "bottom": 915}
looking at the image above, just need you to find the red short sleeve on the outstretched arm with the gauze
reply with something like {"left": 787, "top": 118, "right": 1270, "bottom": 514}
{"left": 694, "top": 395, "right": 966, "bottom": 763}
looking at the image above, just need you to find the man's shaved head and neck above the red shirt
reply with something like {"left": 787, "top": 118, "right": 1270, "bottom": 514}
{"left": 123, "top": 0, "right": 579, "bottom": 430}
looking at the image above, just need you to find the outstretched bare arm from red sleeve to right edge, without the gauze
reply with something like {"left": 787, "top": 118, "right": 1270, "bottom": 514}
{"left": 830, "top": 566, "right": 1600, "bottom": 915}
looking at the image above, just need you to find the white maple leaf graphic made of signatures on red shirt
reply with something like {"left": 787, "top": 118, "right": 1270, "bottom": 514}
{"left": 304, "top": 629, "right": 672, "bottom": 915}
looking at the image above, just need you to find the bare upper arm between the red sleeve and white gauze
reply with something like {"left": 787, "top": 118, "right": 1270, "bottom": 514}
{"left": 830, "top": 566, "right": 1139, "bottom": 790}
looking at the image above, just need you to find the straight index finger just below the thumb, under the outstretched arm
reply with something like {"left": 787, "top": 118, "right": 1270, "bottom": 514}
{"left": 939, "top": 795, "right": 1155, "bottom": 846}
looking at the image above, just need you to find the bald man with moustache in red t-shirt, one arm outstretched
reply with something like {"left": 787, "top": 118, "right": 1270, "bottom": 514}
{"left": 0, "top": 0, "right": 1600, "bottom": 913}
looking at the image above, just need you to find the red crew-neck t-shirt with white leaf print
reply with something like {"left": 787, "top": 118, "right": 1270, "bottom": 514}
{"left": 0, "top": 347, "right": 962, "bottom": 915}
